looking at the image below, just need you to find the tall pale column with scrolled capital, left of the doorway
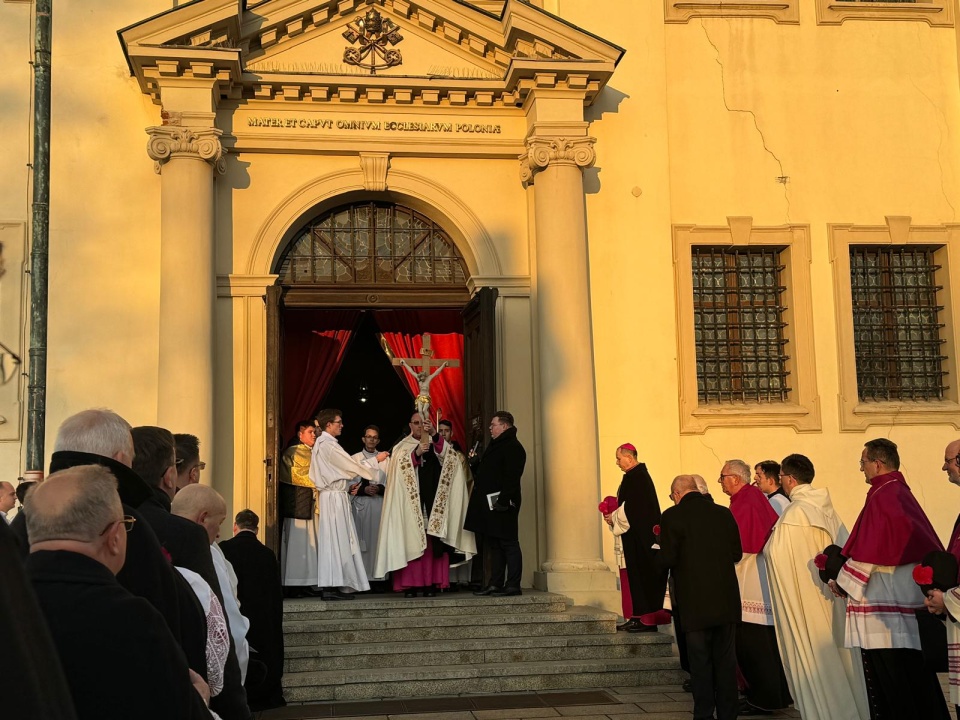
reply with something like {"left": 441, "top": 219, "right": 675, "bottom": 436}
{"left": 147, "top": 125, "right": 223, "bottom": 464}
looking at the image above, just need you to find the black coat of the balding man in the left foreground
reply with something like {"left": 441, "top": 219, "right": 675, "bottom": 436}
{"left": 26, "top": 550, "right": 211, "bottom": 720}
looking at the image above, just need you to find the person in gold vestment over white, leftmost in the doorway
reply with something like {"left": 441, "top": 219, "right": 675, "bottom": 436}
{"left": 280, "top": 420, "right": 320, "bottom": 592}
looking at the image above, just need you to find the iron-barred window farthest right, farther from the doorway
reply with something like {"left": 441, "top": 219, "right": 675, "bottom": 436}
{"left": 850, "top": 245, "right": 947, "bottom": 402}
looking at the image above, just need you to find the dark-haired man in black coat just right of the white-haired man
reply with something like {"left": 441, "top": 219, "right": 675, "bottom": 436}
{"left": 130, "top": 426, "right": 250, "bottom": 720}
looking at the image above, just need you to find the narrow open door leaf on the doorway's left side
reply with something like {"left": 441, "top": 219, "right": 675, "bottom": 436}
{"left": 263, "top": 285, "right": 283, "bottom": 558}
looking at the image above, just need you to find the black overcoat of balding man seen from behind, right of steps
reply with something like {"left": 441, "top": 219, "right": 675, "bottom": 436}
{"left": 652, "top": 491, "right": 743, "bottom": 632}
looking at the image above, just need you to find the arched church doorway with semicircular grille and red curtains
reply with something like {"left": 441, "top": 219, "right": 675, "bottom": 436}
{"left": 267, "top": 200, "right": 495, "bottom": 541}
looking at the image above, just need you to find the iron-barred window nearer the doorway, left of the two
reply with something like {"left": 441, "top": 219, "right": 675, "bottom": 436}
{"left": 691, "top": 246, "right": 790, "bottom": 404}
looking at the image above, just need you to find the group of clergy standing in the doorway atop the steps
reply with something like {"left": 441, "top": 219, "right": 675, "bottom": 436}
{"left": 279, "top": 408, "right": 526, "bottom": 600}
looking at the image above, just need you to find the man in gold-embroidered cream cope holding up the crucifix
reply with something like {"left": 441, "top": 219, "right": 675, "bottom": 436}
{"left": 374, "top": 413, "right": 477, "bottom": 596}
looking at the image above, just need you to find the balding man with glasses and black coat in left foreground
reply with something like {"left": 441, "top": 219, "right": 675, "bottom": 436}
{"left": 26, "top": 465, "right": 211, "bottom": 720}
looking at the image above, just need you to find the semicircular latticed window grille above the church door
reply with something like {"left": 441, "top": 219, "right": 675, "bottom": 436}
{"left": 277, "top": 202, "right": 467, "bottom": 287}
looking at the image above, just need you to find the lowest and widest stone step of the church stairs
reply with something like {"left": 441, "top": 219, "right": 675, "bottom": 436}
{"left": 283, "top": 657, "right": 685, "bottom": 702}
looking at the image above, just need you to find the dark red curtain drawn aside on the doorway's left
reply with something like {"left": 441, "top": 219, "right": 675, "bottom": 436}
{"left": 282, "top": 310, "right": 360, "bottom": 441}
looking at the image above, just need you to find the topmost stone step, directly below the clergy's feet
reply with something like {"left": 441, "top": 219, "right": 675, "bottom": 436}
{"left": 283, "top": 592, "right": 568, "bottom": 621}
